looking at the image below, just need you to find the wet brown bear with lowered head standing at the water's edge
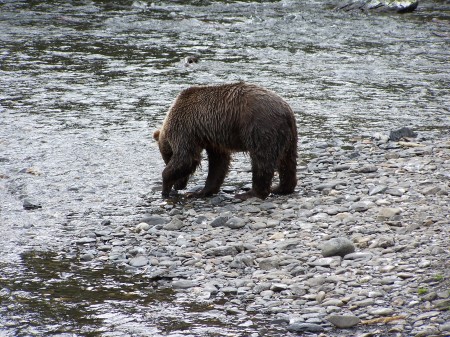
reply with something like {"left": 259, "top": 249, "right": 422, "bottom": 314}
{"left": 153, "top": 82, "right": 297, "bottom": 200}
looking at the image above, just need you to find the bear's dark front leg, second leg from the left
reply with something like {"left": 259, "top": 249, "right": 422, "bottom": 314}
{"left": 190, "top": 149, "right": 231, "bottom": 198}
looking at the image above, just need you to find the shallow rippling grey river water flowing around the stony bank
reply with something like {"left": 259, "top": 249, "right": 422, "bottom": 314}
{"left": 0, "top": 0, "right": 450, "bottom": 336}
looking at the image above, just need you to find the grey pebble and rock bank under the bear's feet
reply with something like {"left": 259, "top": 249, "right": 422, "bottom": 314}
{"left": 74, "top": 134, "right": 450, "bottom": 337}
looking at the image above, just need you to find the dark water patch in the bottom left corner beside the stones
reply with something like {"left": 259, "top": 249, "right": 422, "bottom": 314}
{"left": 0, "top": 251, "right": 288, "bottom": 336}
